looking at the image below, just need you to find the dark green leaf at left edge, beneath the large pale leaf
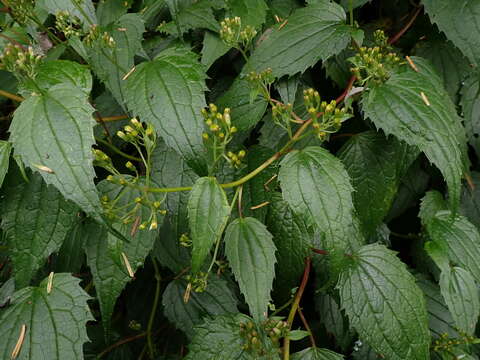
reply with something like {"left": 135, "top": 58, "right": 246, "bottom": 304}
{"left": 1, "top": 170, "right": 78, "bottom": 289}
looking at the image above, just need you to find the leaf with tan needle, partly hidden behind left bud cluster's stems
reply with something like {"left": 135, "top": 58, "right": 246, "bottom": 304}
{"left": 83, "top": 181, "right": 163, "bottom": 336}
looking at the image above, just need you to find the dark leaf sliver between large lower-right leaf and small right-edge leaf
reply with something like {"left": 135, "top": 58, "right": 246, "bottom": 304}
{"left": 417, "top": 276, "right": 458, "bottom": 338}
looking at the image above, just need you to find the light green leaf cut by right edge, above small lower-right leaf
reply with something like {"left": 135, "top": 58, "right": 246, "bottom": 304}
{"left": 426, "top": 211, "right": 480, "bottom": 282}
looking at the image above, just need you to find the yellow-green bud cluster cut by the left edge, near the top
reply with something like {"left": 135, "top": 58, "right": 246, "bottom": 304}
{"left": 0, "top": 43, "right": 42, "bottom": 79}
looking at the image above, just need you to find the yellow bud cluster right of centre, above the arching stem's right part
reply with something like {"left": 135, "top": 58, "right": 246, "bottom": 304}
{"left": 303, "top": 88, "right": 351, "bottom": 141}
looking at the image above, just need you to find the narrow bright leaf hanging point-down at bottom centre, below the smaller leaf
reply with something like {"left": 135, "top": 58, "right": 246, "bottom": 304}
{"left": 225, "top": 218, "right": 276, "bottom": 321}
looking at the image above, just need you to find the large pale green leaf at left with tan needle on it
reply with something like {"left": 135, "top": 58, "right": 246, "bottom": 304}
{"left": 9, "top": 85, "right": 103, "bottom": 218}
